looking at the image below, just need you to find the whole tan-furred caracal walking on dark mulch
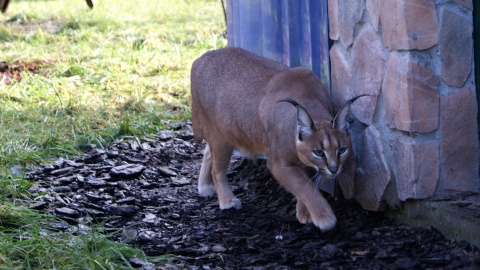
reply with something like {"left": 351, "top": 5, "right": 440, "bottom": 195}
{"left": 191, "top": 48, "right": 352, "bottom": 231}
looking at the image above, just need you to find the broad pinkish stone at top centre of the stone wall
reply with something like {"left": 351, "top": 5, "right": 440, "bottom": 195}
{"left": 378, "top": 0, "right": 438, "bottom": 50}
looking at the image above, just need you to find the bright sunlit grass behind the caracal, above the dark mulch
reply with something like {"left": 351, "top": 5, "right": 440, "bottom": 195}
{"left": 0, "top": 1, "right": 225, "bottom": 163}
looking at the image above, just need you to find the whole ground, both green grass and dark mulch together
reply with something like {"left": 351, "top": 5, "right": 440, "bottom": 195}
{"left": 0, "top": 0, "right": 476, "bottom": 269}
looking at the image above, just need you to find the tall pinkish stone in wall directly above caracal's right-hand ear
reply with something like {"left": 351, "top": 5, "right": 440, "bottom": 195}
{"left": 350, "top": 25, "right": 387, "bottom": 125}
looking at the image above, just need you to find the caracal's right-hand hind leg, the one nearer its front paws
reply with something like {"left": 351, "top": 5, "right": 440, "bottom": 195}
{"left": 209, "top": 143, "right": 242, "bottom": 209}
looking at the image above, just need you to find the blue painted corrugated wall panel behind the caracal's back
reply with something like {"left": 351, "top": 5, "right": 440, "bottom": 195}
{"left": 226, "top": 0, "right": 330, "bottom": 91}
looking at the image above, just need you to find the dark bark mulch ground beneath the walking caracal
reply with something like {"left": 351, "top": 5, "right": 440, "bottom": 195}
{"left": 28, "top": 123, "right": 480, "bottom": 269}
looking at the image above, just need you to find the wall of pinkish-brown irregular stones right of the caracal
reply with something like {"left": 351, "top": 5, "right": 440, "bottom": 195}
{"left": 328, "top": 0, "right": 480, "bottom": 210}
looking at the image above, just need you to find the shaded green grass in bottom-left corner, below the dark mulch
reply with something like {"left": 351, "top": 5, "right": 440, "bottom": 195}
{"left": 0, "top": 208, "right": 147, "bottom": 269}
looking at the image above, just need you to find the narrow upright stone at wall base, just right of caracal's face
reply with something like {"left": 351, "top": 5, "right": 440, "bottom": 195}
{"left": 355, "top": 126, "right": 392, "bottom": 211}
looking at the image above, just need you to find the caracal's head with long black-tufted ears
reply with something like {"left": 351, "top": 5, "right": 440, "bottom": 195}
{"left": 282, "top": 97, "right": 358, "bottom": 178}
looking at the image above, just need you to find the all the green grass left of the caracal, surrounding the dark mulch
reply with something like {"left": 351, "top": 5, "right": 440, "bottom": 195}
{"left": 0, "top": 0, "right": 226, "bottom": 269}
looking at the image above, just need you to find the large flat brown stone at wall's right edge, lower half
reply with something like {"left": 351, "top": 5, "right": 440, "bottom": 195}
{"left": 440, "top": 87, "right": 479, "bottom": 191}
